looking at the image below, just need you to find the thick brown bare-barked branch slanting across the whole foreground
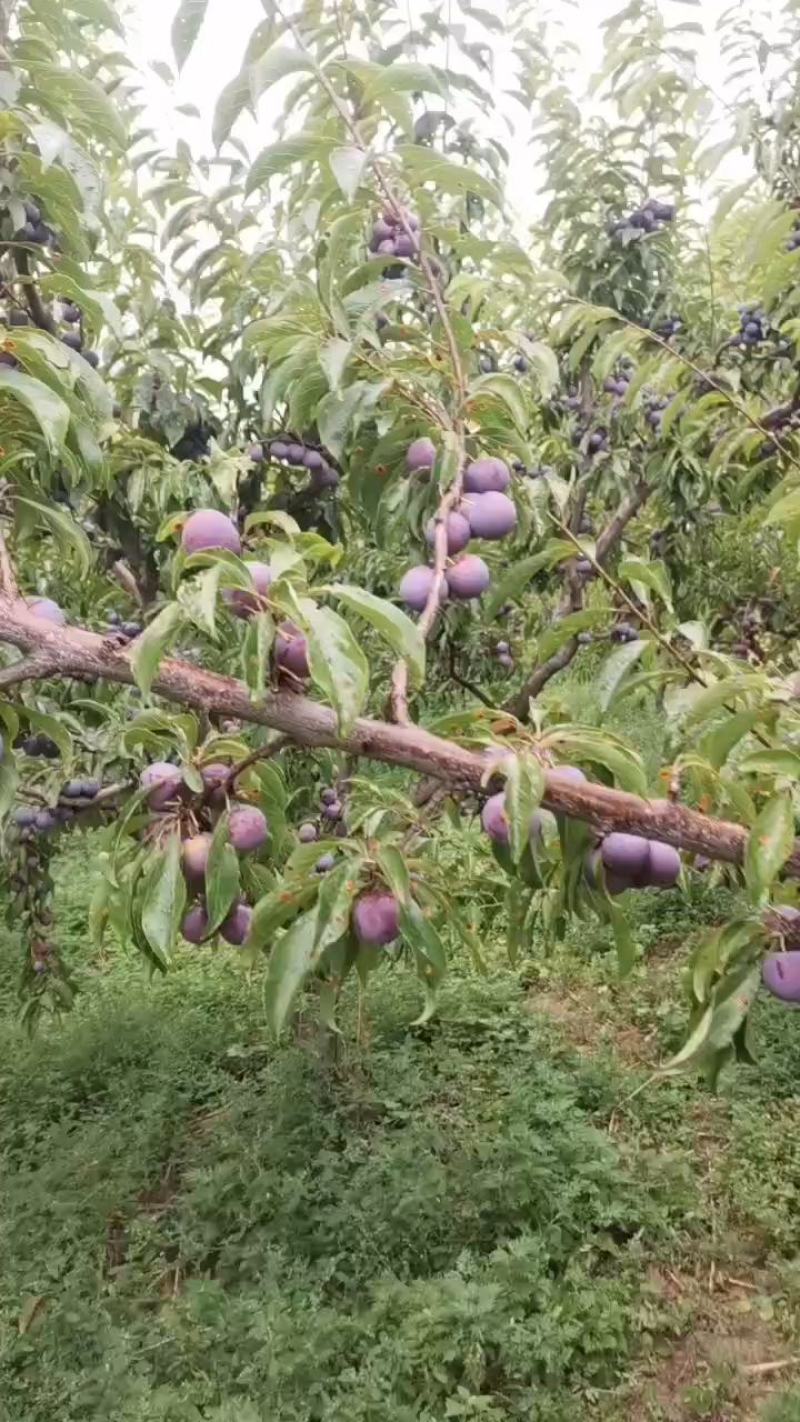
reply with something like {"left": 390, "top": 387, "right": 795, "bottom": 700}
{"left": 0, "top": 597, "right": 800, "bottom": 877}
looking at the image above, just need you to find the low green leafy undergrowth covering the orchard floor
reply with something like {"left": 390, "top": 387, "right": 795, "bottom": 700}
{"left": 0, "top": 860, "right": 800, "bottom": 1422}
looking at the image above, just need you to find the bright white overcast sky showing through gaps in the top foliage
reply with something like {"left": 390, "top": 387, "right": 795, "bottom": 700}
{"left": 129, "top": 0, "right": 755, "bottom": 220}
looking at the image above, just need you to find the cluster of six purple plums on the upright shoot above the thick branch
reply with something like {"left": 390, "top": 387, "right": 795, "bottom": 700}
{"left": 399, "top": 439, "right": 517, "bottom": 611}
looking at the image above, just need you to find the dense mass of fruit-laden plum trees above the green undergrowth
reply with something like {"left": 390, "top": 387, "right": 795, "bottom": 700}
{"left": 0, "top": 0, "right": 800, "bottom": 1074}
